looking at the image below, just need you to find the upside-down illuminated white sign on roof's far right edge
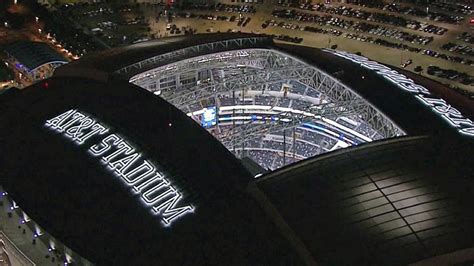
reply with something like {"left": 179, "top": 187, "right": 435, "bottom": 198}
{"left": 325, "top": 49, "right": 474, "bottom": 136}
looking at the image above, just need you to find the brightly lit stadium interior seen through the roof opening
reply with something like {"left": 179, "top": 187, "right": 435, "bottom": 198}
{"left": 130, "top": 49, "right": 405, "bottom": 171}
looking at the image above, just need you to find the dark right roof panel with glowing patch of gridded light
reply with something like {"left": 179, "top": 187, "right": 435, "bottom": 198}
{"left": 256, "top": 137, "right": 474, "bottom": 265}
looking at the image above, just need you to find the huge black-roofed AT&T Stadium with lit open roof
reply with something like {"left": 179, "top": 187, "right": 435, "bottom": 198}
{"left": 0, "top": 34, "right": 474, "bottom": 265}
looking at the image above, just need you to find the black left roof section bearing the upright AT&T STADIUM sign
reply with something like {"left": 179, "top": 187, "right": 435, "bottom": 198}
{"left": 0, "top": 77, "right": 299, "bottom": 265}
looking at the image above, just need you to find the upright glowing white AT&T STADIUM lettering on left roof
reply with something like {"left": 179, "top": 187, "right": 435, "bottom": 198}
{"left": 45, "top": 109, "right": 194, "bottom": 226}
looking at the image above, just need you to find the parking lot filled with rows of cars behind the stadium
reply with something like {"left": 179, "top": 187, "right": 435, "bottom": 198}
{"left": 36, "top": 0, "right": 474, "bottom": 94}
